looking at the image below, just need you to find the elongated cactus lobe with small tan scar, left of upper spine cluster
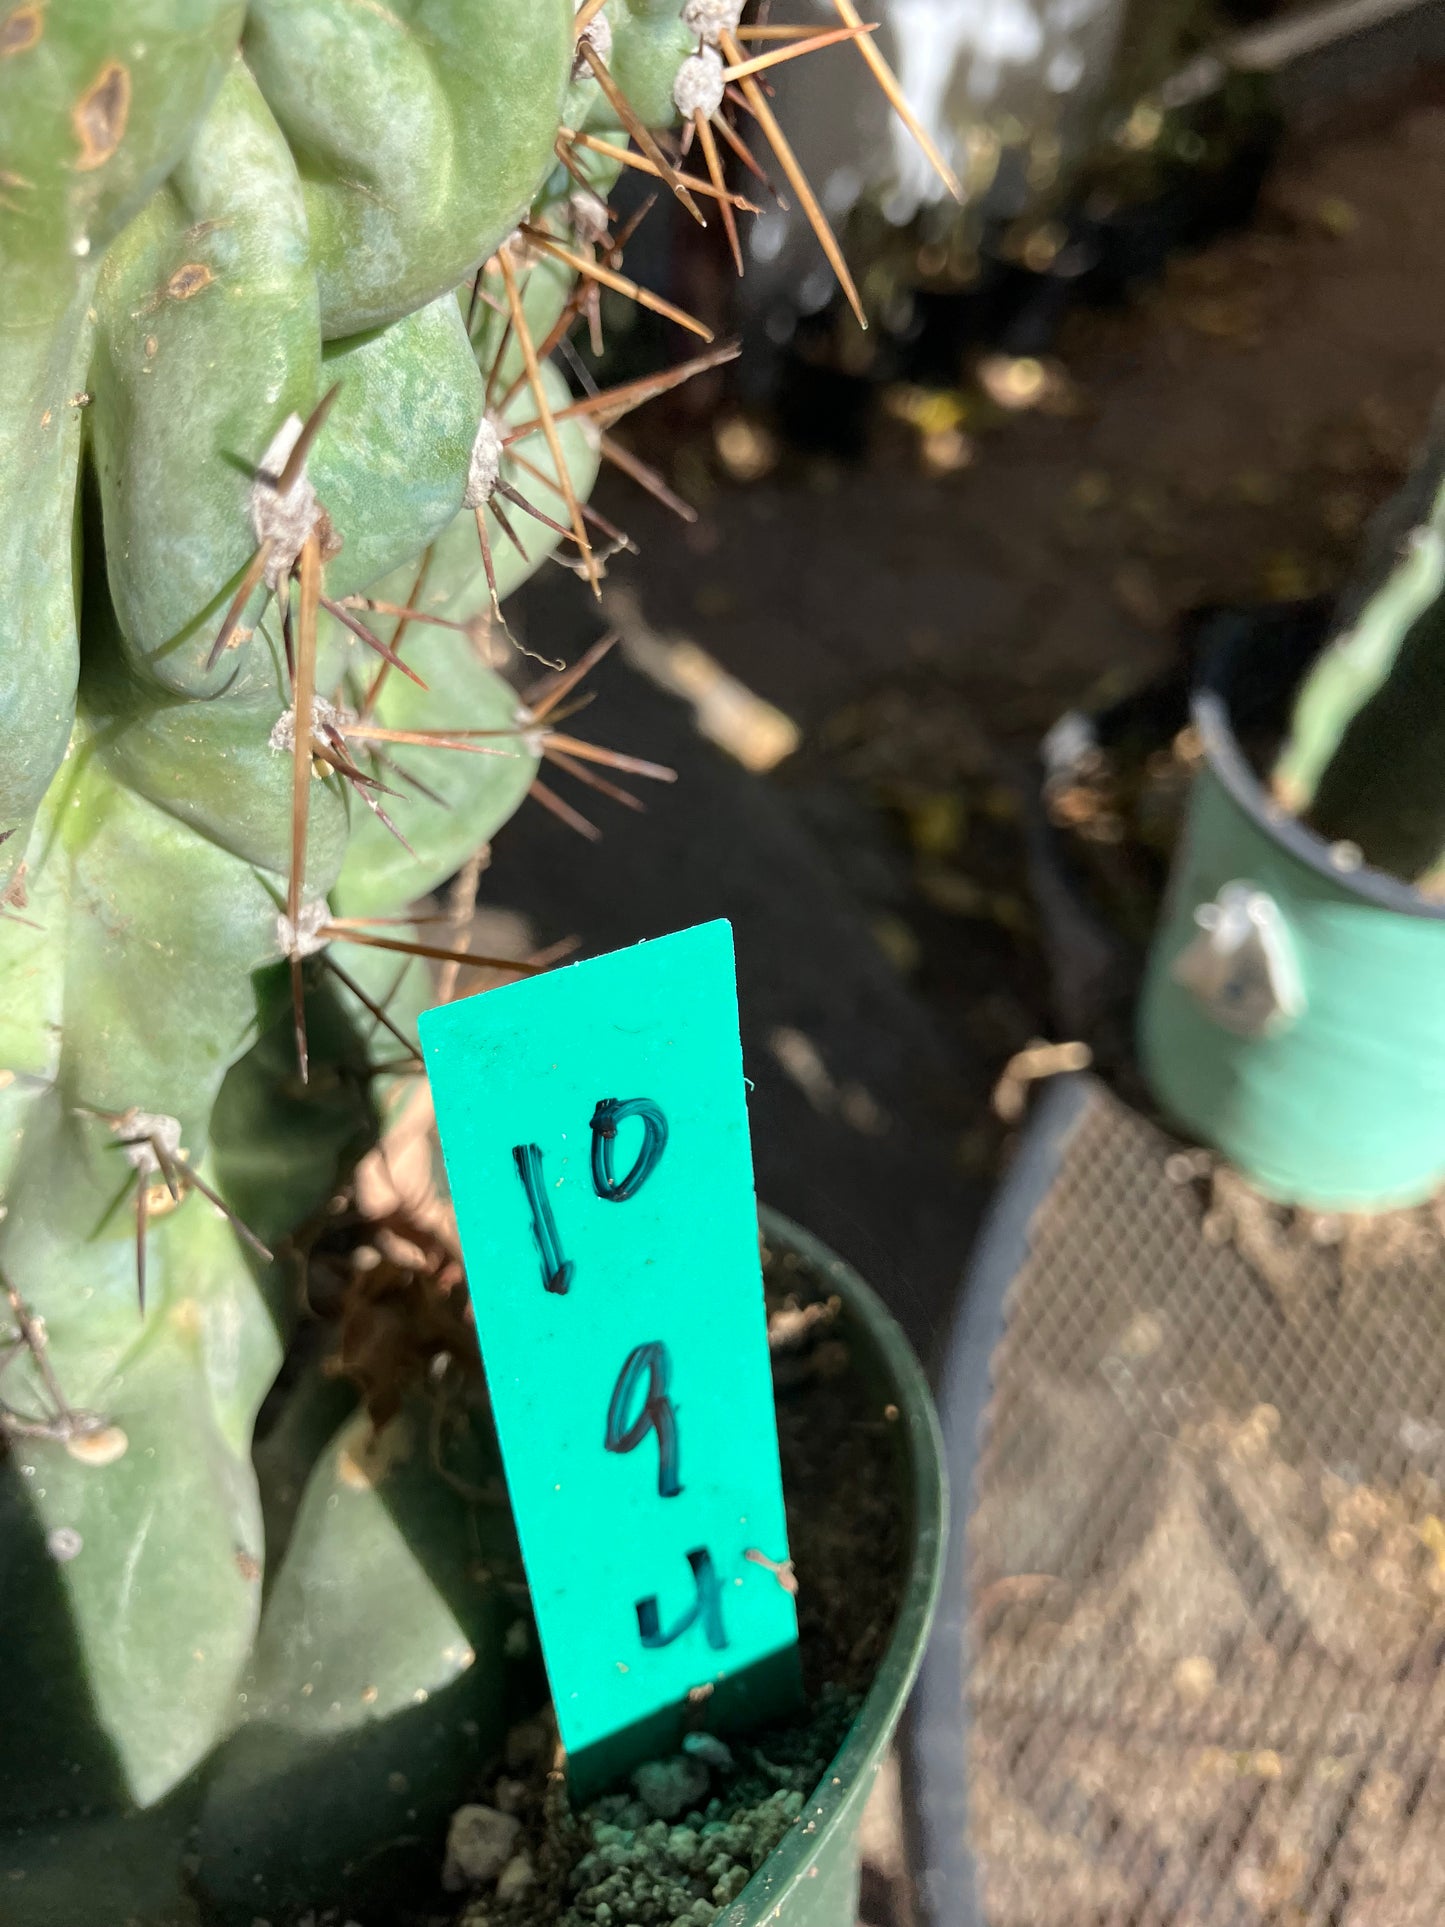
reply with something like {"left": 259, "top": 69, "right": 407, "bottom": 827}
{"left": 91, "top": 60, "right": 322, "bottom": 696}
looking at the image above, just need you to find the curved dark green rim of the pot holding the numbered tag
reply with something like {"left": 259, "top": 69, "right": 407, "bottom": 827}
{"left": 715, "top": 1206, "right": 948, "bottom": 1927}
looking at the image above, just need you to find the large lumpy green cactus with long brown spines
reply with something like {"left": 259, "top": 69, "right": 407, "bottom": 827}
{"left": 0, "top": 0, "right": 951, "bottom": 1927}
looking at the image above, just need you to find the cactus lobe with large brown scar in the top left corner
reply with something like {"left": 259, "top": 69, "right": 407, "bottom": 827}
{"left": 0, "top": 0, "right": 243, "bottom": 863}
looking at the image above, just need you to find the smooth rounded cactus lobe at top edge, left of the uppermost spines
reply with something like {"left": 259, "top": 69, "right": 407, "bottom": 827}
{"left": 245, "top": 0, "right": 572, "bottom": 339}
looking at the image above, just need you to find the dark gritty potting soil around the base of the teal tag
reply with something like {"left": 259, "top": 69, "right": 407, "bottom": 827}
{"left": 450, "top": 1251, "right": 906, "bottom": 1927}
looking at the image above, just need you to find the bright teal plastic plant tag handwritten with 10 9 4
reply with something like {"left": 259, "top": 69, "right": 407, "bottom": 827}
{"left": 422, "top": 923, "right": 800, "bottom": 1796}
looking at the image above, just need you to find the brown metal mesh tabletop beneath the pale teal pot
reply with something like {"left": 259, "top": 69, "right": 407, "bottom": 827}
{"left": 969, "top": 1093, "right": 1445, "bottom": 1927}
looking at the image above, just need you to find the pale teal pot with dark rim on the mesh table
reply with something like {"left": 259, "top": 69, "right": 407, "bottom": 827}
{"left": 1139, "top": 638, "right": 1445, "bottom": 1212}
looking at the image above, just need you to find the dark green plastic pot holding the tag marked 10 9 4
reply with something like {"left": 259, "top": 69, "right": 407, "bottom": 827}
{"left": 717, "top": 1210, "right": 948, "bottom": 1927}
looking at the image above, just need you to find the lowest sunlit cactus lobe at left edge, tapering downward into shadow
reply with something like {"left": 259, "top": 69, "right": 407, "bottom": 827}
{"left": 0, "top": 1125, "right": 281, "bottom": 1823}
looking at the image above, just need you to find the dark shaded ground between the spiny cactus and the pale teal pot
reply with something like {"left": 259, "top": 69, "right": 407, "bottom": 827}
{"left": 486, "top": 75, "right": 1445, "bottom": 1379}
